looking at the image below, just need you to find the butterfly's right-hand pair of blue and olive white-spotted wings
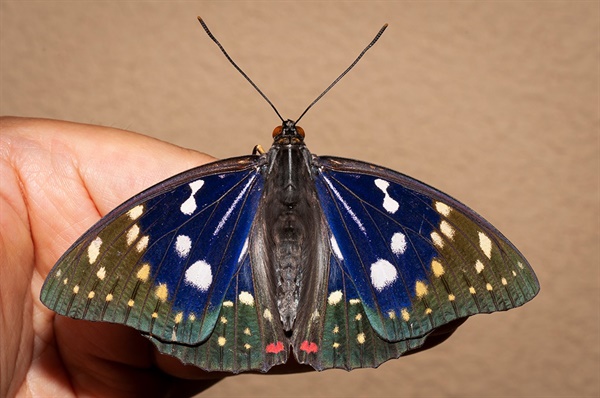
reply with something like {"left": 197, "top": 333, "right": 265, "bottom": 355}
{"left": 295, "top": 157, "right": 539, "bottom": 369}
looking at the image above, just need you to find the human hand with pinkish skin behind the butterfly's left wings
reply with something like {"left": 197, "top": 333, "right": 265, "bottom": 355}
{"left": 0, "top": 118, "right": 239, "bottom": 396}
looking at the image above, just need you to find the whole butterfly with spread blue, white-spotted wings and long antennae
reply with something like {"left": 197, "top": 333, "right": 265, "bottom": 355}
{"left": 41, "top": 20, "right": 539, "bottom": 373}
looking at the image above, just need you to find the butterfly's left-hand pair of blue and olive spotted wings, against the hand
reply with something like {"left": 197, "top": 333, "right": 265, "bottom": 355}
{"left": 41, "top": 156, "right": 287, "bottom": 371}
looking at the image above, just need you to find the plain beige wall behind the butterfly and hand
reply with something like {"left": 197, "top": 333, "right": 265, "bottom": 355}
{"left": 0, "top": 0, "right": 600, "bottom": 397}
